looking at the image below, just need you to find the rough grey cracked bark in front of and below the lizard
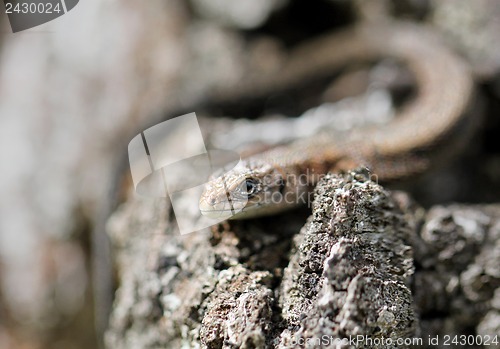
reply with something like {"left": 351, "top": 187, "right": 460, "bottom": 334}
{"left": 106, "top": 171, "right": 500, "bottom": 348}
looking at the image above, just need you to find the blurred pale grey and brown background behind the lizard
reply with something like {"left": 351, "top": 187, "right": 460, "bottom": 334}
{"left": 0, "top": 0, "right": 500, "bottom": 349}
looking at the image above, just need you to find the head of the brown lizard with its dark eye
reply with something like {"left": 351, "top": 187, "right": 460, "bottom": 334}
{"left": 199, "top": 160, "right": 287, "bottom": 218}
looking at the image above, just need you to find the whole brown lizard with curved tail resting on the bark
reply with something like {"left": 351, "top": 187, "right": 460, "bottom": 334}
{"left": 199, "top": 22, "right": 477, "bottom": 219}
